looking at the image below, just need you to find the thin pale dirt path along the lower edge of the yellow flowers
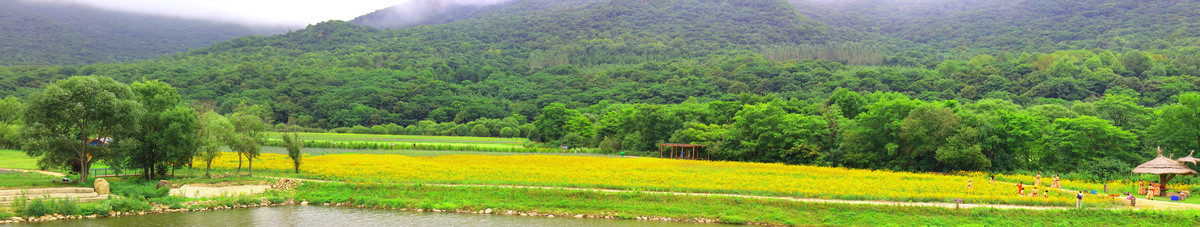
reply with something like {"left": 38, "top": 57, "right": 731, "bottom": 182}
{"left": 266, "top": 177, "right": 1073, "bottom": 210}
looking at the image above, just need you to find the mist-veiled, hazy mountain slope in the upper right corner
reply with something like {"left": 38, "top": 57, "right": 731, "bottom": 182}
{"left": 788, "top": 0, "right": 1200, "bottom": 54}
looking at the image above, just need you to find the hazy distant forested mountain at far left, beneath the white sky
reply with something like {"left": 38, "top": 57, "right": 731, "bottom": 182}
{"left": 0, "top": 0, "right": 276, "bottom": 65}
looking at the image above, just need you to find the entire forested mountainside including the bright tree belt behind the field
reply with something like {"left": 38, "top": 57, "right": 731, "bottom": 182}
{"left": 9, "top": 0, "right": 1200, "bottom": 172}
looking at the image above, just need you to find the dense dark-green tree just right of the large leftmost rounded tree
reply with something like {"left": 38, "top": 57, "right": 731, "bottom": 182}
{"left": 126, "top": 80, "right": 198, "bottom": 179}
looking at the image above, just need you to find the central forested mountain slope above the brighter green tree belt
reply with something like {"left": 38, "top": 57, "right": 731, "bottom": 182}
{"left": 0, "top": 0, "right": 824, "bottom": 127}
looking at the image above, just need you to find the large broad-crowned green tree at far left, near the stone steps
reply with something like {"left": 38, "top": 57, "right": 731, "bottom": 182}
{"left": 23, "top": 76, "right": 145, "bottom": 181}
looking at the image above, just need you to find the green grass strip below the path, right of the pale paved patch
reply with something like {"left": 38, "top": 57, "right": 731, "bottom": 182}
{"left": 295, "top": 183, "right": 1200, "bottom": 226}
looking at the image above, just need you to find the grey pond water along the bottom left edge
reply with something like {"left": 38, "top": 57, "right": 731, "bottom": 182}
{"left": 9, "top": 205, "right": 721, "bottom": 227}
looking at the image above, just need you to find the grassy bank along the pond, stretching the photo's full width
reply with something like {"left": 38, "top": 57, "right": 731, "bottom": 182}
{"left": 7, "top": 183, "right": 1200, "bottom": 226}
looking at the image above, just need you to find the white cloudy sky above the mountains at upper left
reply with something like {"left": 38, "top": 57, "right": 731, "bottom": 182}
{"left": 28, "top": 0, "right": 432, "bottom": 28}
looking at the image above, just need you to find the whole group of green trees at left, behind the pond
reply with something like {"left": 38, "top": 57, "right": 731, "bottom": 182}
{"left": 0, "top": 76, "right": 302, "bottom": 181}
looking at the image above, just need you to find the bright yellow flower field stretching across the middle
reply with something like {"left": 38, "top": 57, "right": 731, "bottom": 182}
{"left": 212, "top": 154, "right": 1103, "bottom": 205}
